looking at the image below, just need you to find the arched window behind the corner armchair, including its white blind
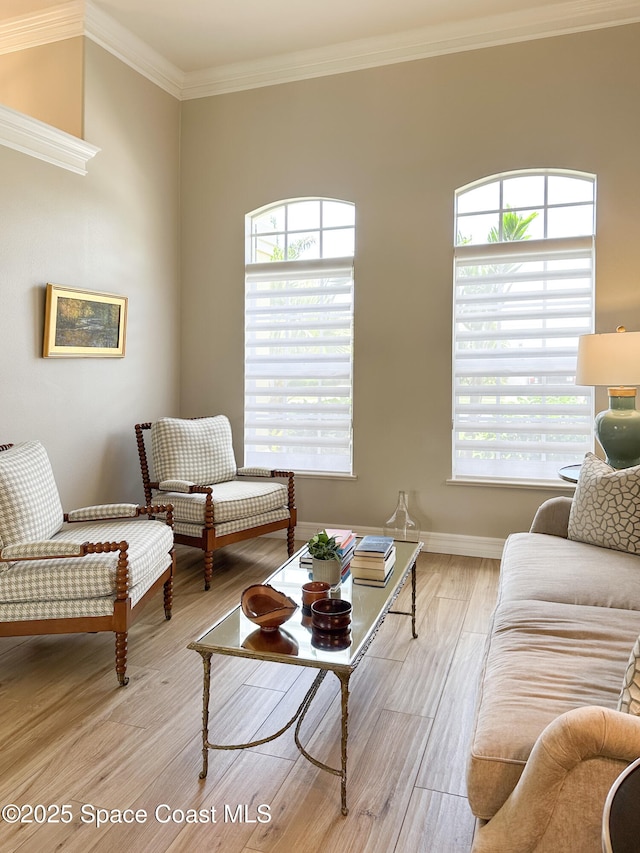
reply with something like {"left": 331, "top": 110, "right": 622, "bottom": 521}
{"left": 244, "top": 198, "right": 355, "bottom": 474}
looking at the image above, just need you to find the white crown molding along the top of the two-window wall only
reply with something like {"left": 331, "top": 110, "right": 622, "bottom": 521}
{"left": 181, "top": 0, "right": 640, "bottom": 100}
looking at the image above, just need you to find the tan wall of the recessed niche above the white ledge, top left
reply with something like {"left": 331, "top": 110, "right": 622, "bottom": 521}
{"left": 0, "top": 37, "right": 84, "bottom": 138}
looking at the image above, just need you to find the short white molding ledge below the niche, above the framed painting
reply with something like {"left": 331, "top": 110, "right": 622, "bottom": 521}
{"left": 0, "top": 105, "right": 100, "bottom": 175}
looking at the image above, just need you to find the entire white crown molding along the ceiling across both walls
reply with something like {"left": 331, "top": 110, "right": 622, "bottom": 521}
{"left": 0, "top": 0, "right": 640, "bottom": 100}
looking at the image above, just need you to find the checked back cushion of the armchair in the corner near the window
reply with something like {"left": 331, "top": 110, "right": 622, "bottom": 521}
{"left": 151, "top": 415, "right": 237, "bottom": 486}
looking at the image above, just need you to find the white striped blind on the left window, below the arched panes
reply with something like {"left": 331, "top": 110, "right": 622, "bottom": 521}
{"left": 245, "top": 257, "right": 353, "bottom": 474}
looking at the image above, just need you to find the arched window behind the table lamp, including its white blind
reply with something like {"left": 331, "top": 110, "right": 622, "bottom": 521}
{"left": 452, "top": 170, "right": 595, "bottom": 481}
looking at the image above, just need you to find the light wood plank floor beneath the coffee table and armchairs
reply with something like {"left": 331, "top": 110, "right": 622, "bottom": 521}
{"left": 0, "top": 539, "right": 498, "bottom": 853}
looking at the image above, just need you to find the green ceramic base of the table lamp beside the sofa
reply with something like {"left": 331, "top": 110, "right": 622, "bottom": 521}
{"left": 596, "top": 388, "right": 640, "bottom": 468}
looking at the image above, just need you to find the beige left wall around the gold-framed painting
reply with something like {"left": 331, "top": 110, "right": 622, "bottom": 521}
{"left": 0, "top": 42, "right": 180, "bottom": 508}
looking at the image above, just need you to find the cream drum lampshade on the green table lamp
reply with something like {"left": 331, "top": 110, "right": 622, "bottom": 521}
{"left": 576, "top": 327, "right": 640, "bottom": 386}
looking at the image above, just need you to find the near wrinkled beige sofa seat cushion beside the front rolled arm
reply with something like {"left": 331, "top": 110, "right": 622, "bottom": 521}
{"left": 467, "top": 596, "right": 640, "bottom": 820}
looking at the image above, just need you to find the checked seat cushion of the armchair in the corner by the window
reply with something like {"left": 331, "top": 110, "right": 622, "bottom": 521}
{"left": 154, "top": 480, "right": 287, "bottom": 529}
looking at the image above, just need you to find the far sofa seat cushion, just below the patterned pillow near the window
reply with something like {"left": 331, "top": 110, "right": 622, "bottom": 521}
{"left": 499, "top": 533, "right": 640, "bottom": 612}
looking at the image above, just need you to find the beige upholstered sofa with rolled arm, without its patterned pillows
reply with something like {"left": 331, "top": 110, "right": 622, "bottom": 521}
{"left": 467, "top": 498, "right": 640, "bottom": 853}
